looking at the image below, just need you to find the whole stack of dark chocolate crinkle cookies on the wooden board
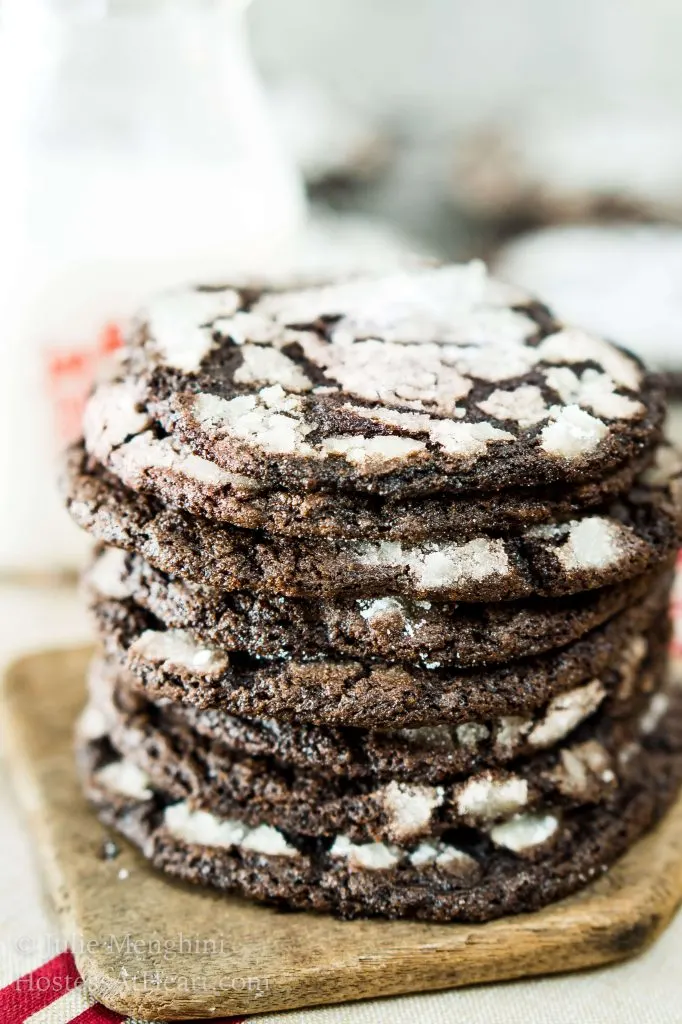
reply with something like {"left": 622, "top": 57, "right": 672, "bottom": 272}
{"left": 63, "top": 263, "right": 682, "bottom": 921}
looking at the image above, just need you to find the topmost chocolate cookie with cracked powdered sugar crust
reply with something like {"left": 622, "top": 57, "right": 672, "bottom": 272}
{"left": 85, "top": 262, "right": 663, "bottom": 496}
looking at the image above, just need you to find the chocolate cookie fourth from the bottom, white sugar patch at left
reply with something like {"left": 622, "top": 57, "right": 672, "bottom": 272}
{"left": 84, "top": 583, "right": 669, "bottom": 728}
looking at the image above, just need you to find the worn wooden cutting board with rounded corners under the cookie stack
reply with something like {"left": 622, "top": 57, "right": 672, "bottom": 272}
{"left": 2, "top": 648, "right": 682, "bottom": 1020}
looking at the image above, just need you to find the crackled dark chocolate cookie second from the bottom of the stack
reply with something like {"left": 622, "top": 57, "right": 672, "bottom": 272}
{"left": 80, "top": 647, "right": 667, "bottom": 843}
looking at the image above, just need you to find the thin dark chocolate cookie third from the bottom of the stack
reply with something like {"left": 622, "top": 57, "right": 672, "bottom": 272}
{"left": 83, "top": 628, "right": 670, "bottom": 783}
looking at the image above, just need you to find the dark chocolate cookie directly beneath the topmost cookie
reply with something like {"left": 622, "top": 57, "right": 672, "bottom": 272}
{"left": 74, "top": 415, "right": 657, "bottom": 541}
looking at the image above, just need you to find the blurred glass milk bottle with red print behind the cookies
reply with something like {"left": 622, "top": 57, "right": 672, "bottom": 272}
{"left": 0, "top": 0, "right": 303, "bottom": 572}
